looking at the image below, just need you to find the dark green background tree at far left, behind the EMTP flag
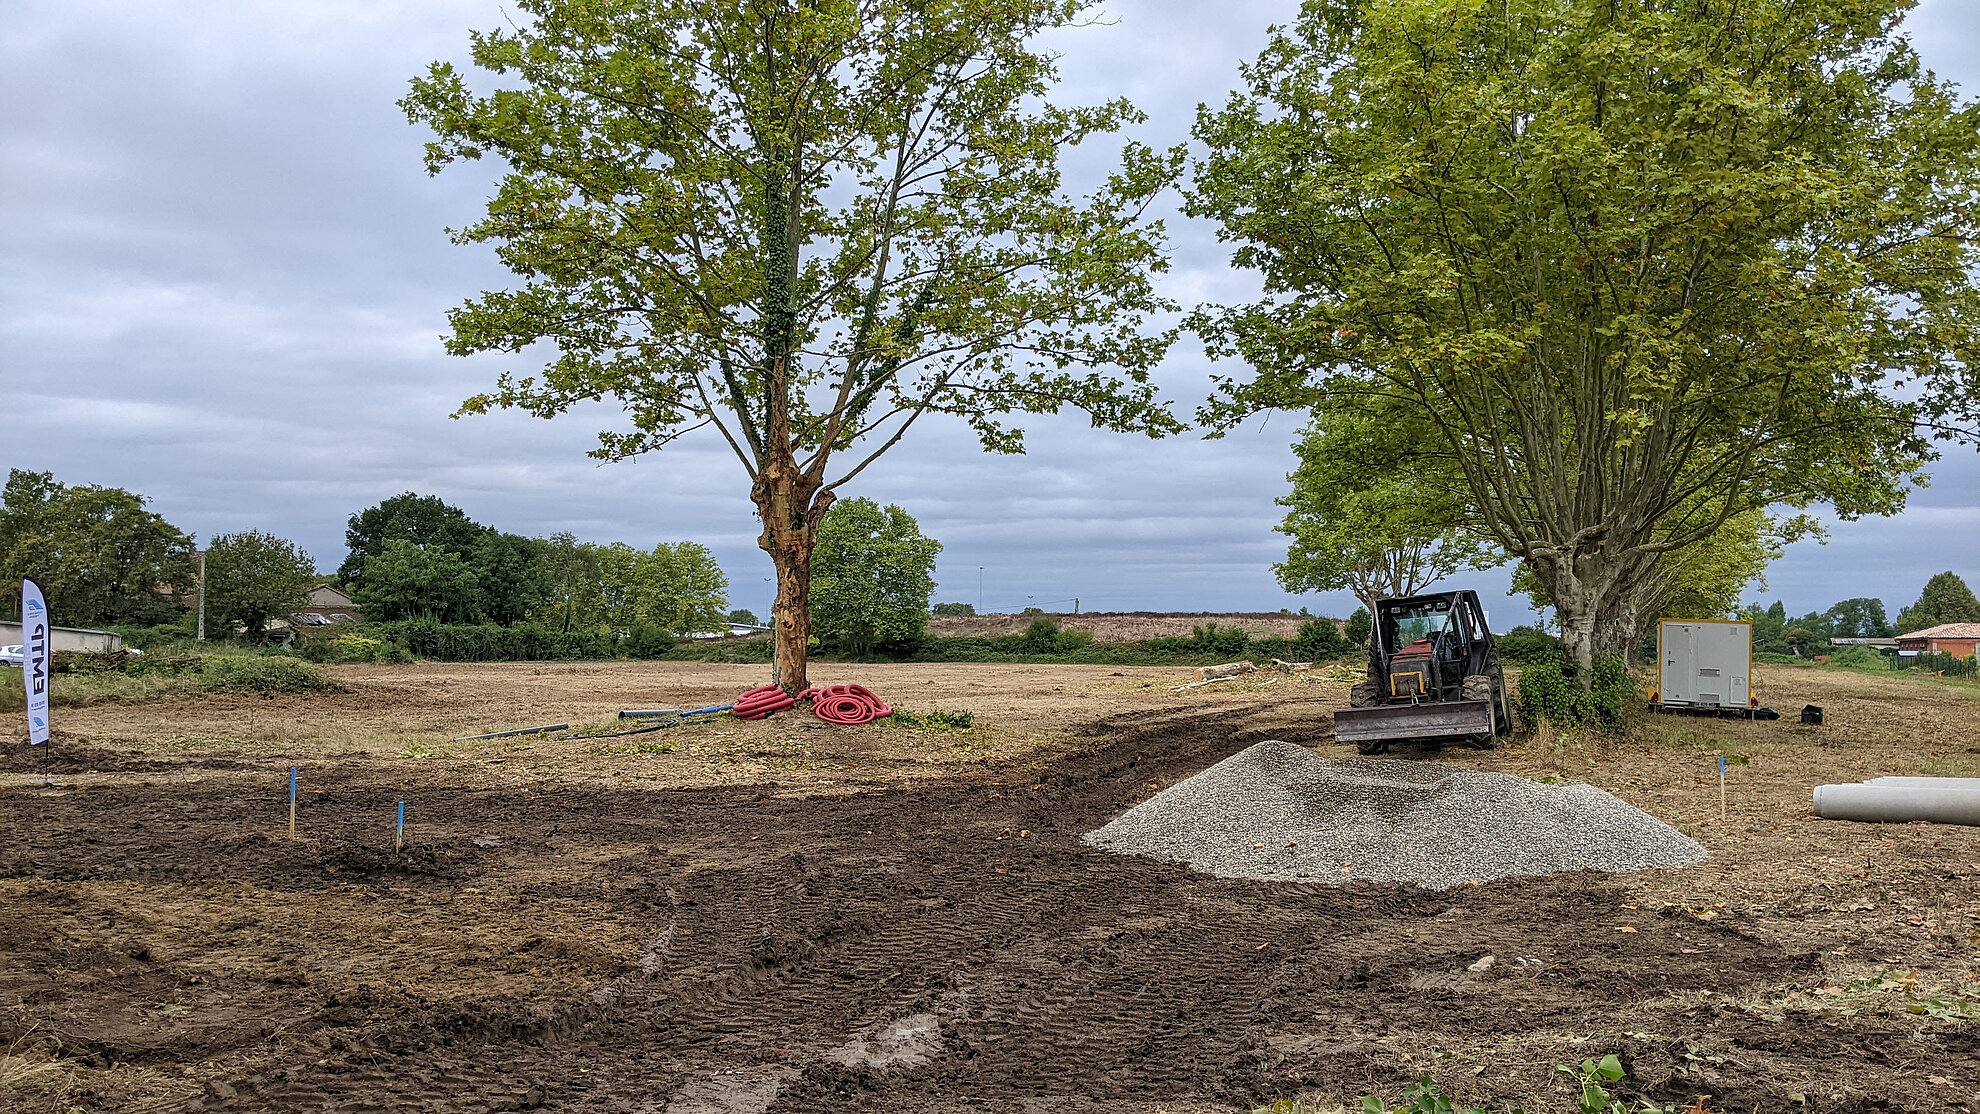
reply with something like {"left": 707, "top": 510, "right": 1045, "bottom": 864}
{"left": 0, "top": 469, "right": 194, "bottom": 625}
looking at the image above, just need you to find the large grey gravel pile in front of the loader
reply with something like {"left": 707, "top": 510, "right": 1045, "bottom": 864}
{"left": 1085, "top": 740, "right": 1705, "bottom": 890}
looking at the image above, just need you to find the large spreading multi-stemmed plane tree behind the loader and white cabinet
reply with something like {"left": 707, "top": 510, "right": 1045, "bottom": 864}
{"left": 1190, "top": 0, "right": 1980, "bottom": 667}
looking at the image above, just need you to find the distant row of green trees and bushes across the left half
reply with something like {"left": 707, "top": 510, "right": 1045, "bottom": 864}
{"left": 0, "top": 469, "right": 958, "bottom": 659}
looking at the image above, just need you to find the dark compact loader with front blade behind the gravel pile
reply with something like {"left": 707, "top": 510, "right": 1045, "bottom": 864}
{"left": 1335, "top": 590, "right": 1513, "bottom": 754}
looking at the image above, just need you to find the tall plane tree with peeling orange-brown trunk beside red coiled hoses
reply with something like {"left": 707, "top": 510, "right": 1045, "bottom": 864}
{"left": 404, "top": 0, "right": 1180, "bottom": 689}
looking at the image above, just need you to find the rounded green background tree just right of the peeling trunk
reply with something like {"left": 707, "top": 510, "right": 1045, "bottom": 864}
{"left": 812, "top": 499, "right": 946, "bottom": 653}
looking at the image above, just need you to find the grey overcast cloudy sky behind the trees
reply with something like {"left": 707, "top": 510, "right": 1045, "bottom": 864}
{"left": 0, "top": 0, "right": 1980, "bottom": 625}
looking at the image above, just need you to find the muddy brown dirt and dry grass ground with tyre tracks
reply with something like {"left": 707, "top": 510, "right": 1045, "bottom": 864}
{"left": 0, "top": 663, "right": 1980, "bottom": 1114}
